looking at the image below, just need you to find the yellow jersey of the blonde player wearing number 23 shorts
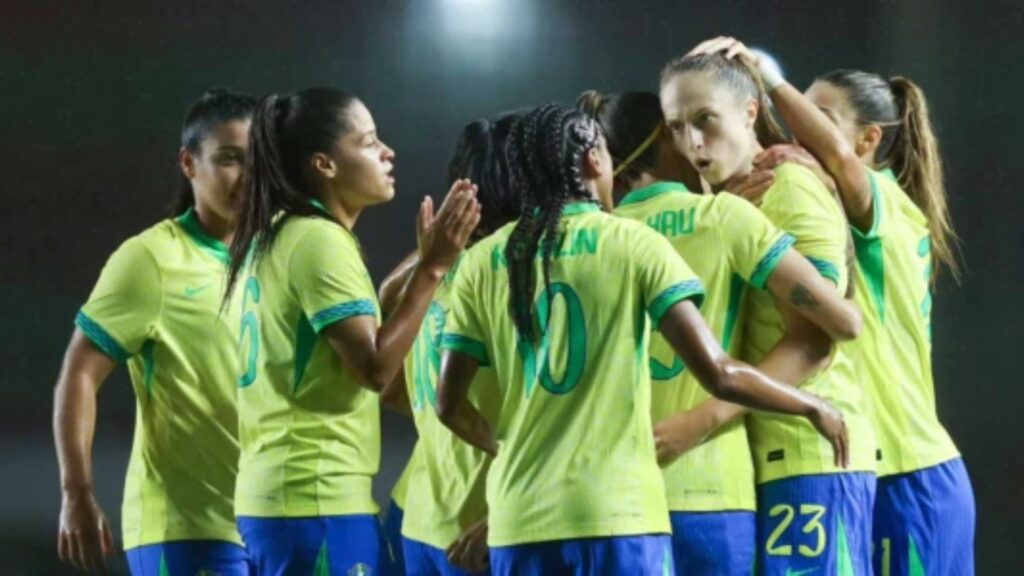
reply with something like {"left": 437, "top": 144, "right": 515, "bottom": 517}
{"left": 743, "top": 164, "right": 876, "bottom": 483}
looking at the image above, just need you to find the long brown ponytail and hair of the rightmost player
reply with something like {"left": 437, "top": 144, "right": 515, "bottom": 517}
{"left": 817, "top": 70, "right": 959, "bottom": 281}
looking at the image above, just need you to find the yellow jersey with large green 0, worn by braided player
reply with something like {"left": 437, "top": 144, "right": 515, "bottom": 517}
{"left": 441, "top": 203, "right": 703, "bottom": 546}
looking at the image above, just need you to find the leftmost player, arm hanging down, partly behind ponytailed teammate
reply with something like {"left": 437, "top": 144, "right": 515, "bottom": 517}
{"left": 53, "top": 90, "right": 256, "bottom": 575}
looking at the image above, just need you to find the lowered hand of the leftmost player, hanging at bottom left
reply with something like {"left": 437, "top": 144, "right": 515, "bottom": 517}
{"left": 57, "top": 485, "right": 117, "bottom": 574}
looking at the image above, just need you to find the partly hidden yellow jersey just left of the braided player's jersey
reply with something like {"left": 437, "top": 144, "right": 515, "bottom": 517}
{"left": 401, "top": 260, "right": 499, "bottom": 549}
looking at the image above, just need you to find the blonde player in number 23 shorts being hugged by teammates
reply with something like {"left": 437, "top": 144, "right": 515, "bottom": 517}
{"left": 660, "top": 47, "right": 874, "bottom": 575}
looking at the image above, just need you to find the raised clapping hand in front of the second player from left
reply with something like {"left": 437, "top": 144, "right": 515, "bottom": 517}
{"left": 416, "top": 179, "right": 480, "bottom": 274}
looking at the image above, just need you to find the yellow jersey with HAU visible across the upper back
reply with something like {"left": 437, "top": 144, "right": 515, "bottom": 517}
{"left": 615, "top": 182, "right": 794, "bottom": 511}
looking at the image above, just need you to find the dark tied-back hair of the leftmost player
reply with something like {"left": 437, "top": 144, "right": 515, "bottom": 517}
{"left": 171, "top": 88, "right": 256, "bottom": 216}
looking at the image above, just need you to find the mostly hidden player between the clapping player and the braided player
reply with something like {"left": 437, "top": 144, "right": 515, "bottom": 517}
{"left": 381, "top": 114, "right": 520, "bottom": 576}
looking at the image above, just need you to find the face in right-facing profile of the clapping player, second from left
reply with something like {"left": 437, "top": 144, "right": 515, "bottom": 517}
{"left": 331, "top": 100, "right": 394, "bottom": 208}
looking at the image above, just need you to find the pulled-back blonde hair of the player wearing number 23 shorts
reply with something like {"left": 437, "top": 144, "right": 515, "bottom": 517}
{"left": 662, "top": 52, "right": 788, "bottom": 148}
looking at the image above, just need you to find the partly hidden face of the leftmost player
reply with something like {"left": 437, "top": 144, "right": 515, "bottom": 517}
{"left": 184, "top": 120, "right": 250, "bottom": 220}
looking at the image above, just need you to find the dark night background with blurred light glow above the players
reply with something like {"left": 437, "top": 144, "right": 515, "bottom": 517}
{"left": 0, "top": 0, "right": 1024, "bottom": 575}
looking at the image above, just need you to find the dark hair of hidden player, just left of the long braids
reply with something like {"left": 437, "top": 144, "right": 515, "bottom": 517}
{"left": 449, "top": 112, "right": 522, "bottom": 240}
